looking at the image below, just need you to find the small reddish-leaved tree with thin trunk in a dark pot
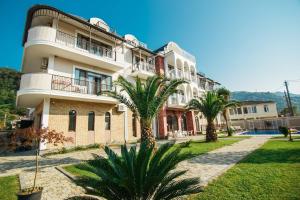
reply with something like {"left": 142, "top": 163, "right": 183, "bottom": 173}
{"left": 11, "top": 127, "right": 73, "bottom": 200}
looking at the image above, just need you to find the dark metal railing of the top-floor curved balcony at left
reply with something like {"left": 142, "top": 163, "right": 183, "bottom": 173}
{"left": 55, "top": 30, "right": 116, "bottom": 60}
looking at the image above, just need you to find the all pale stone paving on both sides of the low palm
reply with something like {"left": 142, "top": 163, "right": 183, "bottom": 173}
{"left": 0, "top": 134, "right": 269, "bottom": 200}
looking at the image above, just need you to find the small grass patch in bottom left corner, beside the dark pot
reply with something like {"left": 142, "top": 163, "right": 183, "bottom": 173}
{"left": 0, "top": 176, "right": 19, "bottom": 200}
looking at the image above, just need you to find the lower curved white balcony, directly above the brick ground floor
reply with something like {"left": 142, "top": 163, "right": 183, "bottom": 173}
{"left": 17, "top": 73, "right": 117, "bottom": 107}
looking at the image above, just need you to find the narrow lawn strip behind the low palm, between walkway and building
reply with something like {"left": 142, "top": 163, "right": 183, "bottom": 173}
{"left": 64, "top": 137, "right": 244, "bottom": 191}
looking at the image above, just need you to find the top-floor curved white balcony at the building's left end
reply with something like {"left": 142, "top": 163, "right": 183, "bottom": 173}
{"left": 25, "top": 26, "right": 124, "bottom": 71}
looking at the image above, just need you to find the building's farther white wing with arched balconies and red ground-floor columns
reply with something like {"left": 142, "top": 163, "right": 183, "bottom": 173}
{"left": 155, "top": 42, "right": 219, "bottom": 137}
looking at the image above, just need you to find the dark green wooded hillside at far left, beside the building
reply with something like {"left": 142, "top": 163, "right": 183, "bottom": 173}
{"left": 0, "top": 67, "right": 25, "bottom": 129}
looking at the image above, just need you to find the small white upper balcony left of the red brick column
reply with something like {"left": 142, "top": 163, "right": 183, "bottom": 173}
{"left": 131, "top": 62, "right": 155, "bottom": 79}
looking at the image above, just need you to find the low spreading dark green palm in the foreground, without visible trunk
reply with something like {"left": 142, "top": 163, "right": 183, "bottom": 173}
{"left": 78, "top": 143, "right": 201, "bottom": 200}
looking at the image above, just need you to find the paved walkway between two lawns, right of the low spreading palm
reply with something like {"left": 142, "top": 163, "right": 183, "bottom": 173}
{"left": 178, "top": 136, "right": 270, "bottom": 186}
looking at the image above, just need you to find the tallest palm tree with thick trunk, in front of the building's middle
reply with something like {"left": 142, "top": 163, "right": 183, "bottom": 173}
{"left": 108, "top": 75, "right": 186, "bottom": 144}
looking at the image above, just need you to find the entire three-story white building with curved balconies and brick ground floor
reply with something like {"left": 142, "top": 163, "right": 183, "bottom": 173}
{"left": 17, "top": 5, "right": 219, "bottom": 148}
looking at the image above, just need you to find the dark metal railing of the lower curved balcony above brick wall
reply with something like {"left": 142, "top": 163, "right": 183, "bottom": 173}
{"left": 51, "top": 75, "right": 113, "bottom": 95}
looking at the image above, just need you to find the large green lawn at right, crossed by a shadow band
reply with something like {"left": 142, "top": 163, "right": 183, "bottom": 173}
{"left": 190, "top": 140, "right": 300, "bottom": 200}
